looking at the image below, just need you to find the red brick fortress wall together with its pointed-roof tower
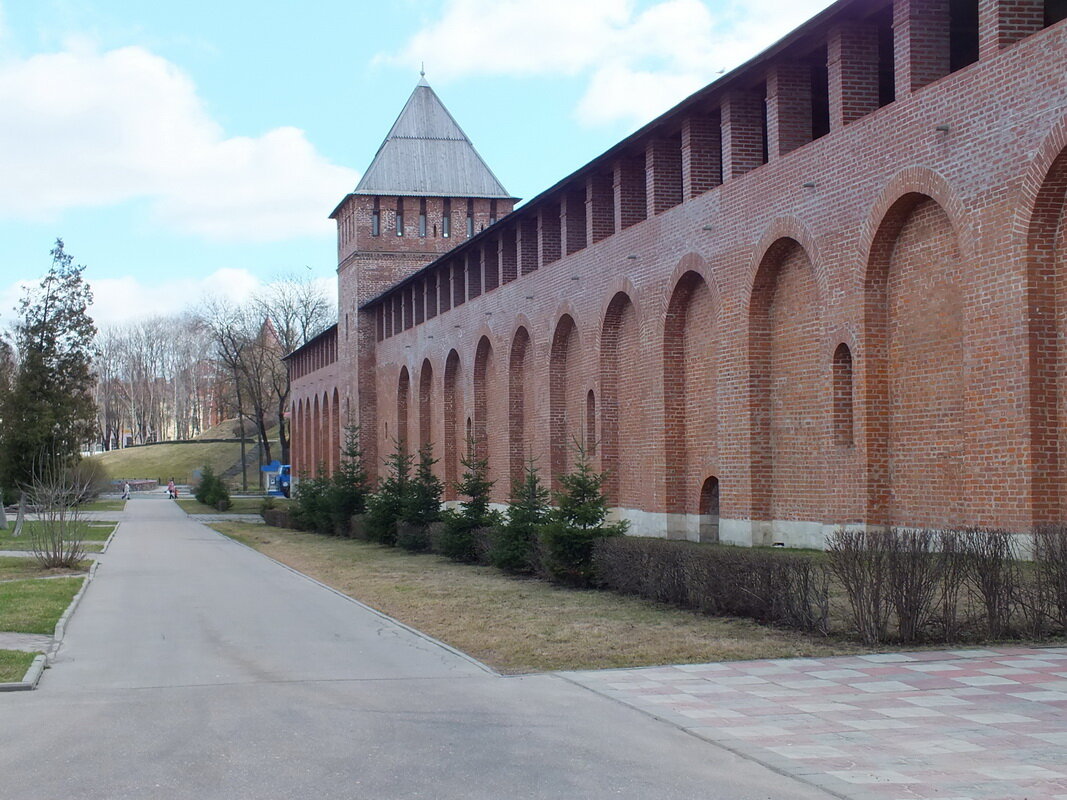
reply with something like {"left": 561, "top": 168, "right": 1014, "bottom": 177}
{"left": 289, "top": 0, "right": 1067, "bottom": 546}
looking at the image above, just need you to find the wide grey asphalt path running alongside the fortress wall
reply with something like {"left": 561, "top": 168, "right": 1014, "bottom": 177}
{"left": 0, "top": 498, "right": 830, "bottom": 800}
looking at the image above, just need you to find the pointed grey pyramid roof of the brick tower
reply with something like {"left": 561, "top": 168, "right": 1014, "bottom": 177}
{"left": 354, "top": 76, "right": 511, "bottom": 198}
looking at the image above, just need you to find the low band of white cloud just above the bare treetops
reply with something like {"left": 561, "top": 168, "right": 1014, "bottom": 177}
{"left": 0, "top": 268, "right": 337, "bottom": 329}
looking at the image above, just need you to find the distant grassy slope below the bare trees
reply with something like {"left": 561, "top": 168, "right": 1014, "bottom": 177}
{"left": 93, "top": 441, "right": 245, "bottom": 486}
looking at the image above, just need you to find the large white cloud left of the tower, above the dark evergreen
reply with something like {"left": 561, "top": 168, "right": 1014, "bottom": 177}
{"left": 0, "top": 41, "right": 357, "bottom": 241}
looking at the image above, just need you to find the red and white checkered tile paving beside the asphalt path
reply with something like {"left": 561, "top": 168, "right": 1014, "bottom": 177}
{"left": 563, "top": 647, "right": 1067, "bottom": 800}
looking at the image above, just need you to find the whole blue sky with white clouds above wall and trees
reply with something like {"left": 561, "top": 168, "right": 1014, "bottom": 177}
{"left": 0, "top": 0, "right": 830, "bottom": 329}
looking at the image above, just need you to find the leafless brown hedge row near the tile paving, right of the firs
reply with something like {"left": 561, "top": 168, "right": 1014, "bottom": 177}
{"left": 593, "top": 526, "right": 1067, "bottom": 644}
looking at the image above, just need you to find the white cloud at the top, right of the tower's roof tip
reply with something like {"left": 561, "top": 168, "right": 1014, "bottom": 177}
{"left": 388, "top": 0, "right": 831, "bottom": 125}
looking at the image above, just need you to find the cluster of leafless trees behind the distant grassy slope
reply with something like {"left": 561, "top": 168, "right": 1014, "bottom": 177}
{"left": 89, "top": 276, "right": 334, "bottom": 475}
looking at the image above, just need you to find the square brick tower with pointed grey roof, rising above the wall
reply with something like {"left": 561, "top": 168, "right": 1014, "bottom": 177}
{"left": 330, "top": 76, "right": 517, "bottom": 470}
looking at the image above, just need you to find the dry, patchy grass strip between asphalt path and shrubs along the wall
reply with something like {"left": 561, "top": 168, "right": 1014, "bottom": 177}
{"left": 211, "top": 523, "right": 862, "bottom": 673}
